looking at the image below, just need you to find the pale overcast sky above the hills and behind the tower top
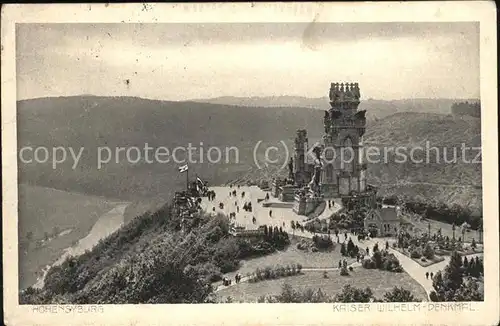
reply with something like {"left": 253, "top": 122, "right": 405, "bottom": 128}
{"left": 16, "top": 23, "right": 479, "bottom": 100}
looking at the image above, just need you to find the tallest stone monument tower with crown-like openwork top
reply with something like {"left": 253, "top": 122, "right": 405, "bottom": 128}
{"left": 321, "top": 83, "right": 366, "bottom": 198}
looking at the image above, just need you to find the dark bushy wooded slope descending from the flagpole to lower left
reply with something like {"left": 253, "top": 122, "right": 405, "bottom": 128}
{"left": 20, "top": 205, "right": 288, "bottom": 304}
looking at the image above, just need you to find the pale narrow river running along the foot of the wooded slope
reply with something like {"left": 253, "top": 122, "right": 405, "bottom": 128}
{"left": 33, "top": 203, "right": 129, "bottom": 288}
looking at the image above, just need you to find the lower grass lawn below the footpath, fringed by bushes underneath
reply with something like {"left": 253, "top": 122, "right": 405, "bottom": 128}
{"left": 217, "top": 267, "right": 427, "bottom": 302}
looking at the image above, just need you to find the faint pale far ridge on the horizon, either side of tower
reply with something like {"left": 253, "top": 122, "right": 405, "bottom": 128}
{"left": 193, "top": 96, "right": 479, "bottom": 118}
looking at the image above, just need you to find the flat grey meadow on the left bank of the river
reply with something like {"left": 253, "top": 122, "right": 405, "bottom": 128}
{"left": 18, "top": 185, "right": 117, "bottom": 288}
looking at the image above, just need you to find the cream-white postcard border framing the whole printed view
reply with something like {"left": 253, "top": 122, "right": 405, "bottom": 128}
{"left": 1, "top": 1, "right": 500, "bottom": 325}
